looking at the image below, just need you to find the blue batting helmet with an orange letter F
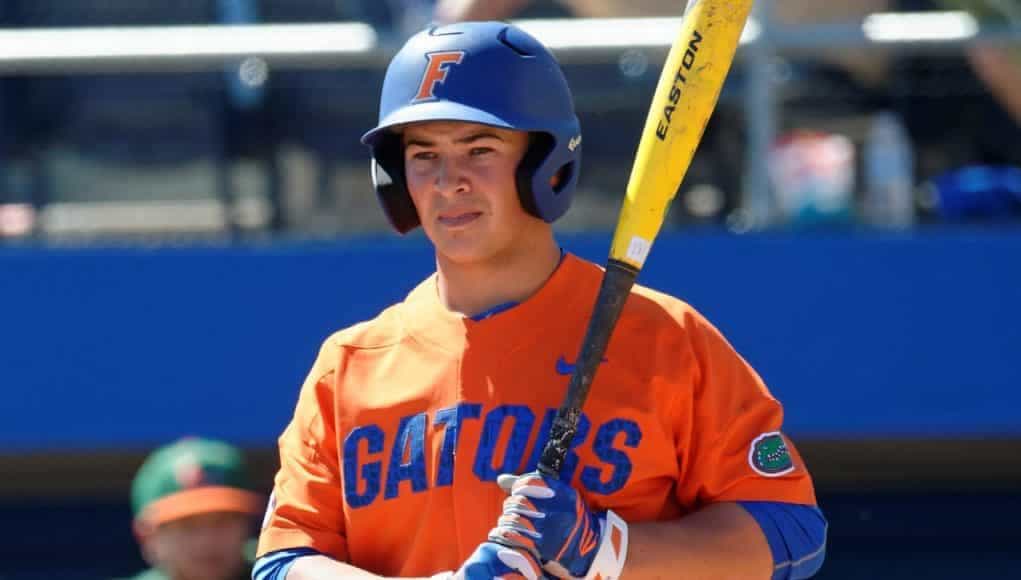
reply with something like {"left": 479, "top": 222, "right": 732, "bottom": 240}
{"left": 361, "top": 22, "right": 581, "bottom": 234}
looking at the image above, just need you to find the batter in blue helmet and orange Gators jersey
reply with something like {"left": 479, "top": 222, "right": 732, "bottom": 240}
{"left": 253, "top": 22, "right": 826, "bottom": 580}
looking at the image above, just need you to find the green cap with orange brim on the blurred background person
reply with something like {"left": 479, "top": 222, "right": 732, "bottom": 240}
{"left": 131, "top": 437, "right": 263, "bottom": 526}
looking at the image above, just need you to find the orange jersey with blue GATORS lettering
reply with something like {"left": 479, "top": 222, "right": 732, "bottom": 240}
{"left": 258, "top": 254, "right": 815, "bottom": 576}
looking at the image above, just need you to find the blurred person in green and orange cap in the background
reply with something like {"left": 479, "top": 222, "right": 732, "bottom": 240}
{"left": 117, "top": 438, "right": 265, "bottom": 580}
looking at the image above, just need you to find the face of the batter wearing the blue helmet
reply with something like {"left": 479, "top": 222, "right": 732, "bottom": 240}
{"left": 402, "top": 122, "right": 549, "bottom": 264}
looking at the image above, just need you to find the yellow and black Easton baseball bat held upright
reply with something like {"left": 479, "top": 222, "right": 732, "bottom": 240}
{"left": 539, "top": 0, "right": 752, "bottom": 477}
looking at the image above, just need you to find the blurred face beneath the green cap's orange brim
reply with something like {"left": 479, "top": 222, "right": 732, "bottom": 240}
{"left": 146, "top": 512, "right": 251, "bottom": 580}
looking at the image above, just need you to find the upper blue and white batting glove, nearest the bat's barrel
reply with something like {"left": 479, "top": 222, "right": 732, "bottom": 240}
{"left": 489, "top": 472, "right": 628, "bottom": 580}
